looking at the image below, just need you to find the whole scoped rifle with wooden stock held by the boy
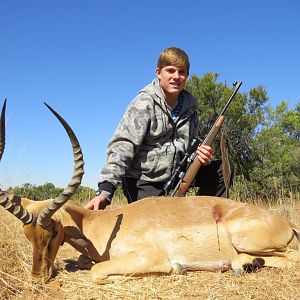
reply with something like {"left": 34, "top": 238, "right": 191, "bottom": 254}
{"left": 164, "top": 81, "right": 242, "bottom": 197}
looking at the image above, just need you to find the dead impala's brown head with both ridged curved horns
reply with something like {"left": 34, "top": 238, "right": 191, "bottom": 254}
{"left": 0, "top": 100, "right": 84, "bottom": 282}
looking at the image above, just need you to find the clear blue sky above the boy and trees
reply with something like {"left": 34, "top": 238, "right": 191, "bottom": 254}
{"left": 0, "top": 0, "right": 300, "bottom": 188}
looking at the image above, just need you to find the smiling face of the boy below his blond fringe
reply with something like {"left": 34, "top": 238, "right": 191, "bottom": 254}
{"left": 156, "top": 66, "right": 188, "bottom": 96}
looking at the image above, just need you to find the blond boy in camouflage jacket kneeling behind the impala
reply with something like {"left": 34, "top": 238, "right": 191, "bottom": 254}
{"left": 85, "top": 47, "right": 226, "bottom": 210}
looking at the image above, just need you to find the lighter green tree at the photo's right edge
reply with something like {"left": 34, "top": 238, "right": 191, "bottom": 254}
{"left": 251, "top": 102, "right": 300, "bottom": 198}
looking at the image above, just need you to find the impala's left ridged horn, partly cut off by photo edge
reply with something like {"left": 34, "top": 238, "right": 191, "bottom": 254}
{"left": 0, "top": 99, "right": 33, "bottom": 225}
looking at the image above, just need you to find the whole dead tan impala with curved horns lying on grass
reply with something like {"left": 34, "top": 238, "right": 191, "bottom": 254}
{"left": 0, "top": 104, "right": 300, "bottom": 283}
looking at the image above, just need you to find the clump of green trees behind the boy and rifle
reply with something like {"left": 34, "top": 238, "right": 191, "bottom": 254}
{"left": 186, "top": 73, "right": 300, "bottom": 202}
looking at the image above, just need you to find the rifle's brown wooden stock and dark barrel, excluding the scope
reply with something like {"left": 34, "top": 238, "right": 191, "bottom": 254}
{"left": 171, "top": 81, "right": 242, "bottom": 197}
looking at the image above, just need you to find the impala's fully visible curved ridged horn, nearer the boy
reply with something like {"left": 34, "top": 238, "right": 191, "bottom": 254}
{"left": 37, "top": 103, "right": 84, "bottom": 227}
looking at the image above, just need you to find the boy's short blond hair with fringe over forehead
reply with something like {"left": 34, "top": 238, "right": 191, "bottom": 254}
{"left": 157, "top": 47, "right": 190, "bottom": 74}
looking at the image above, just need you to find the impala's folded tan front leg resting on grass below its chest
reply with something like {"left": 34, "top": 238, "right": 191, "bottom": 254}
{"left": 91, "top": 252, "right": 173, "bottom": 284}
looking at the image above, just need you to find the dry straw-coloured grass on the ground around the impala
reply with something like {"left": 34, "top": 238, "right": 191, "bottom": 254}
{"left": 0, "top": 199, "right": 300, "bottom": 300}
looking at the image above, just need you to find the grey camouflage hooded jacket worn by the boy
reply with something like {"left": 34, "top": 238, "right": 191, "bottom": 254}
{"left": 99, "top": 79, "right": 199, "bottom": 198}
